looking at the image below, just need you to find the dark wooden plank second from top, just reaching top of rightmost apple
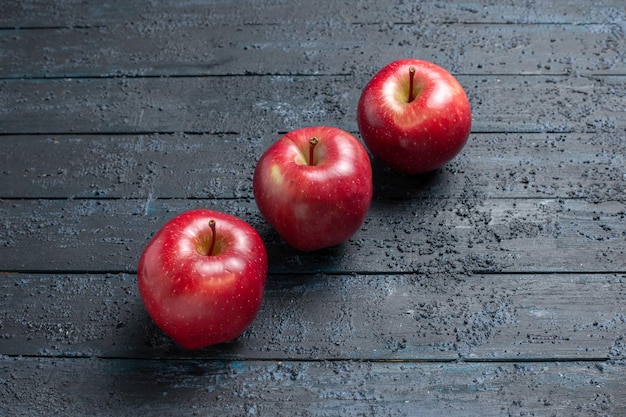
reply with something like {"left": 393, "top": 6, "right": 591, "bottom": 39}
{"left": 0, "top": 20, "right": 626, "bottom": 79}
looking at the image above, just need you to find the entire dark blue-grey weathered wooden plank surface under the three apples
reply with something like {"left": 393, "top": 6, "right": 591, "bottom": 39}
{"left": 0, "top": 0, "right": 626, "bottom": 416}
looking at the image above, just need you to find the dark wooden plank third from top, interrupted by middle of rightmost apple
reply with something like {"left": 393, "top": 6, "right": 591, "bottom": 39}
{"left": 0, "top": 74, "right": 626, "bottom": 137}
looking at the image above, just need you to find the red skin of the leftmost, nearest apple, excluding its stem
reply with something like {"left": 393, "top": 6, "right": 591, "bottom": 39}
{"left": 137, "top": 209, "right": 268, "bottom": 349}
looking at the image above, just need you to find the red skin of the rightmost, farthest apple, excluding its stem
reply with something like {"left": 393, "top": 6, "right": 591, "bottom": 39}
{"left": 357, "top": 58, "right": 472, "bottom": 174}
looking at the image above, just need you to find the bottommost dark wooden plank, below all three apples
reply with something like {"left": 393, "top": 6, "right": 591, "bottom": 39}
{"left": 0, "top": 358, "right": 626, "bottom": 417}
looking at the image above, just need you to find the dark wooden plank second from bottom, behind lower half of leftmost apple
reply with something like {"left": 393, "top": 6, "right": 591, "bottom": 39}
{"left": 0, "top": 273, "right": 626, "bottom": 361}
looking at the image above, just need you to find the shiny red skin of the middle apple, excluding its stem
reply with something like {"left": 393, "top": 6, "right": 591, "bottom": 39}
{"left": 253, "top": 126, "right": 373, "bottom": 252}
